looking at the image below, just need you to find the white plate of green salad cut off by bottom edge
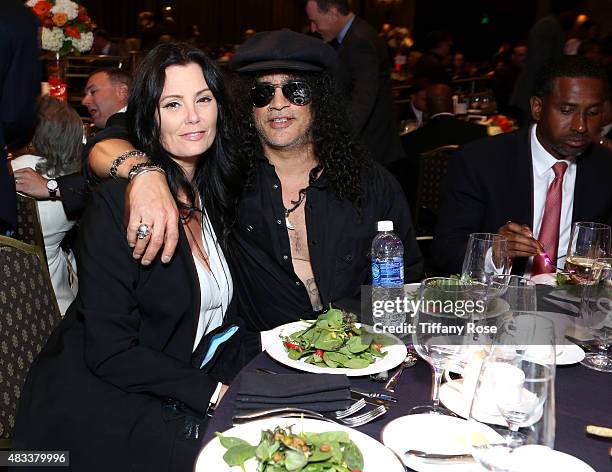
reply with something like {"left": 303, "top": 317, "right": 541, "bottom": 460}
{"left": 195, "top": 418, "right": 404, "bottom": 472}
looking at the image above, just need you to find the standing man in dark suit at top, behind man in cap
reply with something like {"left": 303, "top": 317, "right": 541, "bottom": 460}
{"left": 306, "top": 0, "right": 403, "bottom": 164}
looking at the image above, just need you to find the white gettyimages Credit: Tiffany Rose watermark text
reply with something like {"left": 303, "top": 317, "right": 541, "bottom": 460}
{"left": 372, "top": 297, "right": 497, "bottom": 336}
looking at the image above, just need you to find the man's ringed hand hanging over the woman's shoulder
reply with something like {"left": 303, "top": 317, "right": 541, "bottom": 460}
{"left": 125, "top": 171, "right": 179, "bottom": 265}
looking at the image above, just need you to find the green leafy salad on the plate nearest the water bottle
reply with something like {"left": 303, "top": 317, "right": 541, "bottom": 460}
{"left": 281, "top": 308, "right": 391, "bottom": 369}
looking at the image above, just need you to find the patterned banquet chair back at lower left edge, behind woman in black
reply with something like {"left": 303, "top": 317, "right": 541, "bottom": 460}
{"left": 0, "top": 236, "right": 61, "bottom": 449}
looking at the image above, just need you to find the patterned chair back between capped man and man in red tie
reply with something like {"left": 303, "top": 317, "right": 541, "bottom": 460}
{"left": 414, "top": 144, "right": 459, "bottom": 235}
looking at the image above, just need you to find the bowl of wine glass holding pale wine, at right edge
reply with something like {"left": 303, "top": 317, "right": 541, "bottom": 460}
{"left": 565, "top": 221, "right": 611, "bottom": 285}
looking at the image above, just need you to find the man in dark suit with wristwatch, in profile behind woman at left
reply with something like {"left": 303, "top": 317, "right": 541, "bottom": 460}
{"left": 15, "top": 68, "right": 130, "bottom": 219}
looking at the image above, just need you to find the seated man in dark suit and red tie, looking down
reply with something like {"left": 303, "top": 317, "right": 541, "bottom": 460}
{"left": 432, "top": 56, "right": 612, "bottom": 275}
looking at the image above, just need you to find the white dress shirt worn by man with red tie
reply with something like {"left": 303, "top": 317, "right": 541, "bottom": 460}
{"left": 526, "top": 125, "right": 576, "bottom": 273}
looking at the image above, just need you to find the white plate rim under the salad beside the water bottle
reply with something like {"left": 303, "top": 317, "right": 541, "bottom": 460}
{"left": 261, "top": 321, "right": 407, "bottom": 377}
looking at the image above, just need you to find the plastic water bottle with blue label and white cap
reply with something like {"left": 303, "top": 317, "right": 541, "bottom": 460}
{"left": 372, "top": 221, "right": 406, "bottom": 326}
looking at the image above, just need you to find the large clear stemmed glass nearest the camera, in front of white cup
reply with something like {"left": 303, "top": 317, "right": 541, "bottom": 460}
{"left": 468, "top": 314, "right": 555, "bottom": 471}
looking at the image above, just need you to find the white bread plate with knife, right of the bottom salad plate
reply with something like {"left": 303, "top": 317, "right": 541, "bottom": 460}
{"left": 379, "top": 414, "right": 503, "bottom": 472}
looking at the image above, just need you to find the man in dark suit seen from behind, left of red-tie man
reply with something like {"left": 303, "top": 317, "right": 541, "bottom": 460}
{"left": 387, "top": 84, "right": 487, "bottom": 209}
